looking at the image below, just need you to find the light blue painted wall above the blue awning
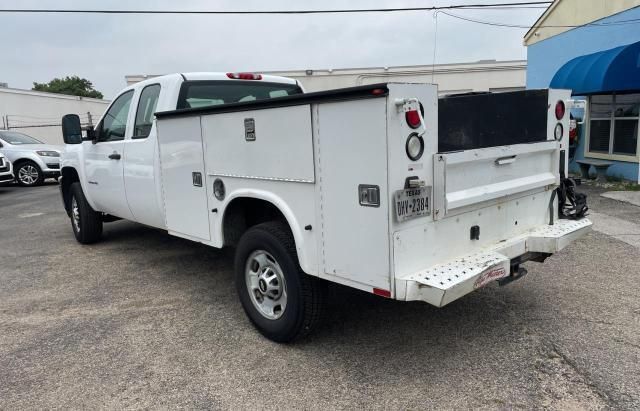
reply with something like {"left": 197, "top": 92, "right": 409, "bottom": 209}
{"left": 527, "top": 7, "right": 640, "bottom": 88}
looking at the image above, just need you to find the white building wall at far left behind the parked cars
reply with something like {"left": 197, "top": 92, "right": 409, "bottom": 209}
{"left": 0, "top": 88, "right": 109, "bottom": 144}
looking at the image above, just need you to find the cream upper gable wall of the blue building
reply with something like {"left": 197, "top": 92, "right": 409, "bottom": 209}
{"left": 524, "top": 0, "right": 640, "bottom": 46}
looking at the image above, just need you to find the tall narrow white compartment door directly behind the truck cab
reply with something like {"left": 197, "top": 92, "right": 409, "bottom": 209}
{"left": 157, "top": 116, "right": 211, "bottom": 241}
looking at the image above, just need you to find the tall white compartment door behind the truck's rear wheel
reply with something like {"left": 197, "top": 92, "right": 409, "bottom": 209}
{"left": 315, "top": 99, "right": 391, "bottom": 290}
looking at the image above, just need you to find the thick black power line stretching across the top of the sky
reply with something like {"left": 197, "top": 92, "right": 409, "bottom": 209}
{"left": 0, "top": 1, "right": 552, "bottom": 15}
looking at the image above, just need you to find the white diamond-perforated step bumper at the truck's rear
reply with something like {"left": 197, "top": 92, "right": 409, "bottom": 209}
{"left": 396, "top": 218, "right": 591, "bottom": 307}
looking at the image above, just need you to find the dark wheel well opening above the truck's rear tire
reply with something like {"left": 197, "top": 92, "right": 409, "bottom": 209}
{"left": 222, "top": 197, "right": 289, "bottom": 246}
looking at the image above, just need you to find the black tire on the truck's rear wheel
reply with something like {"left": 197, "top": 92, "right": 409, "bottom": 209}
{"left": 235, "top": 221, "right": 326, "bottom": 342}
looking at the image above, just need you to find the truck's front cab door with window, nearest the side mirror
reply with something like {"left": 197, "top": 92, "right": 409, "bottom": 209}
{"left": 84, "top": 90, "right": 133, "bottom": 219}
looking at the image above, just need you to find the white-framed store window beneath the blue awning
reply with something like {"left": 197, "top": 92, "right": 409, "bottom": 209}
{"left": 589, "top": 94, "right": 640, "bottom": 157}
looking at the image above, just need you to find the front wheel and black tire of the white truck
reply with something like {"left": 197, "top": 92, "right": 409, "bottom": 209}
{"left": 69, "top": 183, "right": 102, "bottom": 244}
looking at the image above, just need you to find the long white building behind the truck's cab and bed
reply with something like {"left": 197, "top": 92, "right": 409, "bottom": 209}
{"left": 125, "top": 60, "right": 527, "bottom": 94}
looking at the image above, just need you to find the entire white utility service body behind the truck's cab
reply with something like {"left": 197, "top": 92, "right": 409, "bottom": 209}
{"left": 152, "top": 84, "right": 589, "bottom": 306}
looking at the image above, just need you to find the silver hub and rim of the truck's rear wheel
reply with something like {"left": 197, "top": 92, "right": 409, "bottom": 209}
{"left": 245, "top": 250, "right": 287, "bottom": 320}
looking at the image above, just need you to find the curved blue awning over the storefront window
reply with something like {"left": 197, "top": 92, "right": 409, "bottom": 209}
{"left": 549, "top": 41, "right": 640, "bottom": 96}
